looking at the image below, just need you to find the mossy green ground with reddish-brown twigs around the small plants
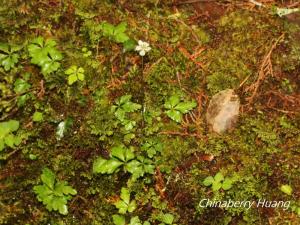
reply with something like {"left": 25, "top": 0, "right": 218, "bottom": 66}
{"left": 0, "top": 0, "right": 300, "bottom": 225}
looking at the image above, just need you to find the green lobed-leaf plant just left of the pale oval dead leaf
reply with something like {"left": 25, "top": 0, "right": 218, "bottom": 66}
{"left": 164, "top": 95, "right": 197, "bottom": 123}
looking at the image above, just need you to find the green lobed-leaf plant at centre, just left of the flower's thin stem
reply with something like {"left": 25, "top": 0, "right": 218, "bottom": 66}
{"left": 111, "top": 95, "right": 142, "bottom": 131}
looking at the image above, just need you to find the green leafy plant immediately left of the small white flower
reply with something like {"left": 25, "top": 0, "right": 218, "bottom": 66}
{"left": 100, "top": 22, "right": 135, "bottom": 51}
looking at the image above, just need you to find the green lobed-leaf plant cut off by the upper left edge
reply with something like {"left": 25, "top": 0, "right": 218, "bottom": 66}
{"left": 0, "top": 43, "right": 22, "bottom": 71}
